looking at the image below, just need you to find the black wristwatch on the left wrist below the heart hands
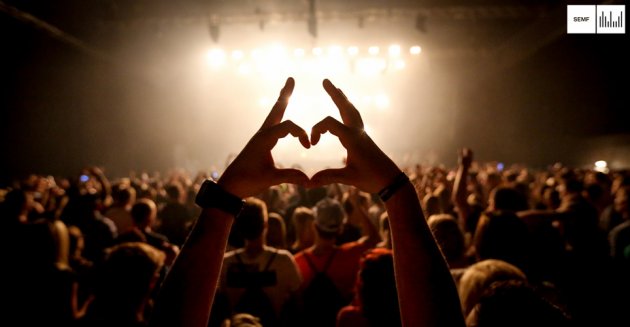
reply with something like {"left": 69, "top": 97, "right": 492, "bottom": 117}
{"left": 195, "top": 179, "right": 245, "bottom": 217}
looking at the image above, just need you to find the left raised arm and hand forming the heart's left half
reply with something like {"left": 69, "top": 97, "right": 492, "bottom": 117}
{"left": 150, "top": 78, "right": 310, "bottom": 327}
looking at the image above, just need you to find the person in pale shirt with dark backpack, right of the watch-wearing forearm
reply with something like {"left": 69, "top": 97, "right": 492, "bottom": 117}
{"left": 212, "top": 198, "right": 302, "bottom": 327}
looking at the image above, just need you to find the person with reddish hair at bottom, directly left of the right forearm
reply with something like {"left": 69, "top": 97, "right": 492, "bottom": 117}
{"left": 337, "top": 249, "right": 402, "bottom": 327}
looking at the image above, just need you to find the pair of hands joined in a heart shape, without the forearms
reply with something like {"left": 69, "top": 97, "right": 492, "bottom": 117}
{"left": 218, "top": 78, "right": 400, "bottom": 198}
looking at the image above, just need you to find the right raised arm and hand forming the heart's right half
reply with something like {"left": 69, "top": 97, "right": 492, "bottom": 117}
{"left": 310, "top": 80, "right": 464, "bottom": 327}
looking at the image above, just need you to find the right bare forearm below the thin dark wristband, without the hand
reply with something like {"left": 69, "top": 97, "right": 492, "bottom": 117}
{"left": 386, "top": 183, "right": 464, "bottom": 326}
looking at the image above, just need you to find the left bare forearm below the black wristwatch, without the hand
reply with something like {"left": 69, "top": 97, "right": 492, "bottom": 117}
{"left": 151, "top": 209, "right": 234, "bottom": 327}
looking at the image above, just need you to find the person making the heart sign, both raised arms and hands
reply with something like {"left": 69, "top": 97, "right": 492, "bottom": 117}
{"left": 151, "top": 78, "right": 464, "bottom": 326}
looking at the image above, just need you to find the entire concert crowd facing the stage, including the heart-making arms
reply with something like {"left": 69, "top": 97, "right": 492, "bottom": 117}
{"left": 0, "top": 79, "right": 630, "bottom": 327}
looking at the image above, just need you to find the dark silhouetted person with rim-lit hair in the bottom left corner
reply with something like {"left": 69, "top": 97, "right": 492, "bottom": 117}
{"left": 0, "top": 219, "right": 84, "bottom": 326}
